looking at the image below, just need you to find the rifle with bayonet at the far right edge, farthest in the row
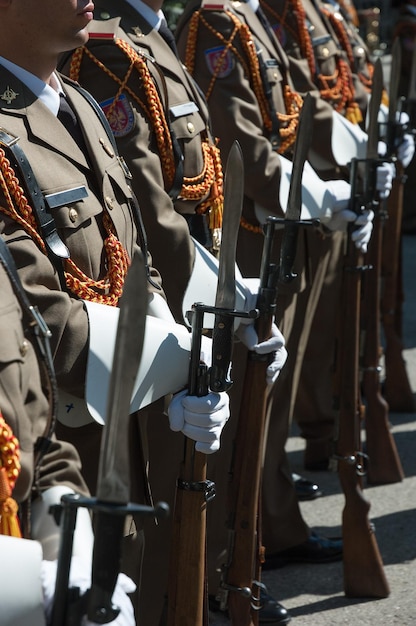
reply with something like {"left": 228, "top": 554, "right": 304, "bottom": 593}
{"left": 381, "top": 38, "right": 416, "bottom": 413}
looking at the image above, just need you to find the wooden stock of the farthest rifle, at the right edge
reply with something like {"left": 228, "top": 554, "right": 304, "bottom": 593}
{"left": 381, "top": 162, "right": 416, "bottom": 413}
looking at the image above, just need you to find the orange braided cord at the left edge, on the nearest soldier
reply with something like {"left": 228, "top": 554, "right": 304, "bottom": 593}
{"left": 0, "top": 411, "right": 22, "bottom": 537}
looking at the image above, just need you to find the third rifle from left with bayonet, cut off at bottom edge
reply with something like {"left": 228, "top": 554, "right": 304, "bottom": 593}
{"left": 218, "top": 95, "right": 313, "bottom": 626}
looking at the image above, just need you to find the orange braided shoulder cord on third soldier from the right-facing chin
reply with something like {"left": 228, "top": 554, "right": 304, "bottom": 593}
{"left": 185, "top": 10, "right": 302, "bottom": 154}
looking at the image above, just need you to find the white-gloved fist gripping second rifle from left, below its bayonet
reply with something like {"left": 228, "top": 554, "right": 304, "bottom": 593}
{"left": 168, "top": 390, "right": 230, "bottom": 454}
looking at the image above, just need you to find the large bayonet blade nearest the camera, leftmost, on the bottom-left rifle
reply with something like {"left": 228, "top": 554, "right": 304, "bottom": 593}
{"left": 97, "top": 252, "right": 147, "bottom": 504}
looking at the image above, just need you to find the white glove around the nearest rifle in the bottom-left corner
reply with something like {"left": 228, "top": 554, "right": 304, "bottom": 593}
{"left": 41, "top": 556, "right": 136, "bottom": 626}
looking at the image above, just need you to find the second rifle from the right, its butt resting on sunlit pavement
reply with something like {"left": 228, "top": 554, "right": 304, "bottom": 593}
{"left": 361, "top": 60, "right": 404, "bottom": 485}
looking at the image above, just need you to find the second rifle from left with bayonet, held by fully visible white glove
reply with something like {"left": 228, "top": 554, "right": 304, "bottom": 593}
{"left": 168, "top": 142, "right": 246, "bottom": 626}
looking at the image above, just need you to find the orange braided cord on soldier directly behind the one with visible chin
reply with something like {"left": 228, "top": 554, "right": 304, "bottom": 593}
{"left": 70, "top": 38, "right": 224, "bottom": 229}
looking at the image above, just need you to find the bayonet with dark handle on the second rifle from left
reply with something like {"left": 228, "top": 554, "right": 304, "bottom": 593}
{"left": 210, "top": 141, "right": 244, "bottom": 391}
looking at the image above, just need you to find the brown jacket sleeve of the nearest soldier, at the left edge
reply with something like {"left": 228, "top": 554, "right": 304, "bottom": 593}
{"left": 0, "top": 265, "right": 86, "bottom": 503}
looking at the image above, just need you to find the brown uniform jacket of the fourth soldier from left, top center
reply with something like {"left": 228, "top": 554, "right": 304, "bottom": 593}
{"left": 176, "top": 0, "right": 333, "bottom": 288}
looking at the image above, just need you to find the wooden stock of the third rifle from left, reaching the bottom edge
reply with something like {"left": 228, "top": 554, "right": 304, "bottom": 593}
{"left": 219, "top": 218, "right": 277, "bottom": 626}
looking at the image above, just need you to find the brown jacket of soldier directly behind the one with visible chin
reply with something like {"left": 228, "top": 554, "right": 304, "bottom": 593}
{"left": 59, "top": 0, "right": 219, "bottom": 321}
